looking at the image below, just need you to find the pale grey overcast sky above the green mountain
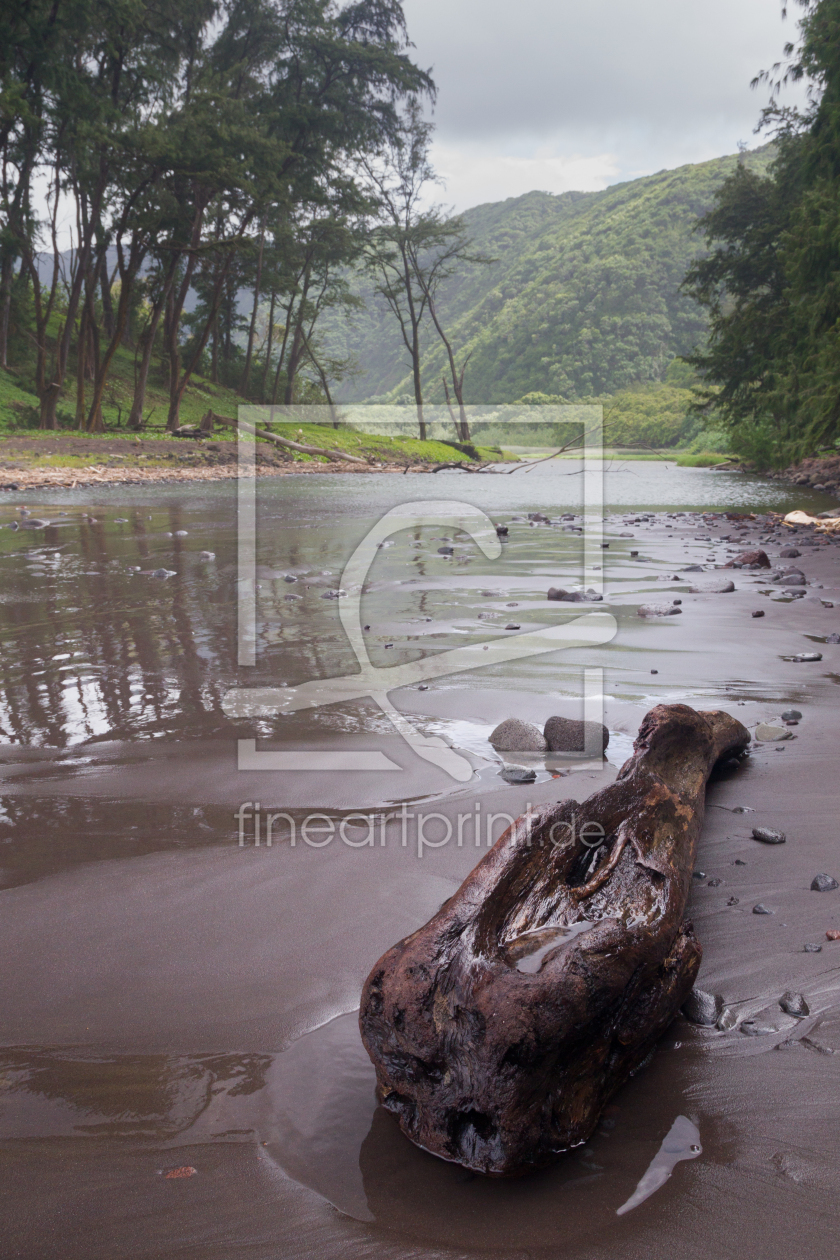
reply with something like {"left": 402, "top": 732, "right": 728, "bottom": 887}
{"left": 404, "top": 0, "right": 797, "bottom": 209}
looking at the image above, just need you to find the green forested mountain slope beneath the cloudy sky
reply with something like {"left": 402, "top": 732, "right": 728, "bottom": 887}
{"left": 330, "top": 146, "right": 773, "bottom": 403}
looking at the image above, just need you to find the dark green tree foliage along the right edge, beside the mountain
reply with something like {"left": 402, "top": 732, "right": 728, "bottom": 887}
{"left": 686, "top": 0, "right": 840, "bottom": 465}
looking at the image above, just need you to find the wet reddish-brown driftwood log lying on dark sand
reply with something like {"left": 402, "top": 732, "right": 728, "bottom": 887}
{"left": 359, "top": 704, "right": 749, "bottom": 1174}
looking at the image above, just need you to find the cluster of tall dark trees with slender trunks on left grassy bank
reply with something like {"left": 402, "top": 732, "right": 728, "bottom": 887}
{"left": 0, "top": 0, "right": 432, "bottom": 431}
